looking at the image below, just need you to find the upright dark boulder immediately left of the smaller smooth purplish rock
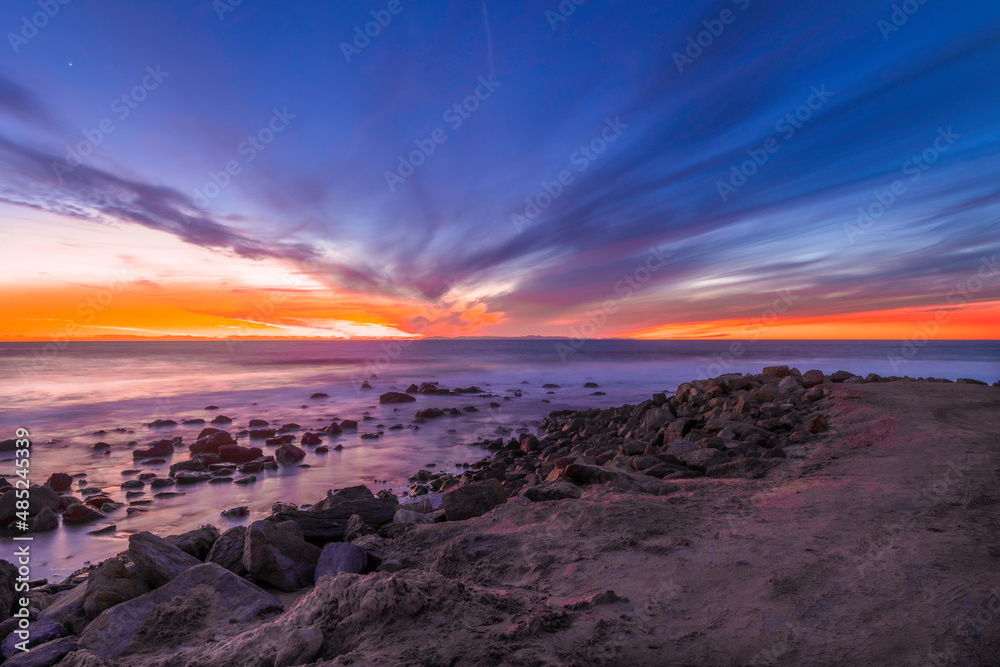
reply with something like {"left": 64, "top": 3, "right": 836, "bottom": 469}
{"left": 243, "top": 520, "right": 321, "bottom": 592}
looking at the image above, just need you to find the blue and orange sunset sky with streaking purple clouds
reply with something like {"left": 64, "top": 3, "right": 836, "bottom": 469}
{"left": 0, "top": 0, "right": 1000, "bottom": 340}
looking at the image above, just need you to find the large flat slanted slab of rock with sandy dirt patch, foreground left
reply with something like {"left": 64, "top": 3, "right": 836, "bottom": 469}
{"left": 80, "top": 563, "right": 283, "bottom": 664}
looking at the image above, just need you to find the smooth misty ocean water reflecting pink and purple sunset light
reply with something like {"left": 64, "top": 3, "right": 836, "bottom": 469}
{"left": 0, "top": 339, "right": 1000, "bottom": 577}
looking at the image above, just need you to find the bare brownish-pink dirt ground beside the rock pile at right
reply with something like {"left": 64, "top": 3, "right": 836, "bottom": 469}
{"left": 362, "top": 382, "right": 1000, "bottom": 665}
